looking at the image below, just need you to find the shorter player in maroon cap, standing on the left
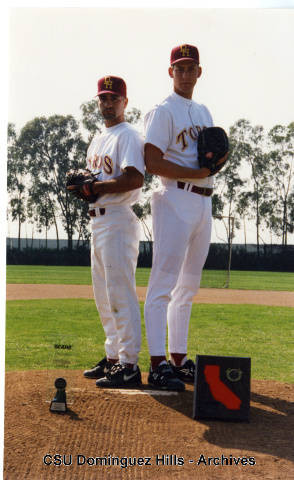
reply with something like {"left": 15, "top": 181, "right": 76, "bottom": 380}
{"left": 84, "top": 76, "right": 145, "bottom": 388}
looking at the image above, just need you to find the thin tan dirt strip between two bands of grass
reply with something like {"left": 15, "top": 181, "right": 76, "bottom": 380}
{"left": 6, "top": 284, "right": 294, "bottom": 307}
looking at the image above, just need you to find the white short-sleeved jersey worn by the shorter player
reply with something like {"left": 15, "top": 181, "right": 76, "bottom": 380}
{"left": 87, "top": 122, "right": 145, "bottom": 209}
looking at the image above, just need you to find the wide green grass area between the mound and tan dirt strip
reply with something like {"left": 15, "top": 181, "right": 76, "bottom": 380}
{"left": 6, "top": 299, "right": 294, "bottom": 382}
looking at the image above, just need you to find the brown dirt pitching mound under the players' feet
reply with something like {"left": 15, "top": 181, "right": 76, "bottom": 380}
{"left": 4, "top": 371, "right": 294, "bottom": 480}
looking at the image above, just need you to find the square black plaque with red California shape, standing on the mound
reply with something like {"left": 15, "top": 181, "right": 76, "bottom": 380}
{"left": 193, "top": 355, "right": 251, "bottom": 422}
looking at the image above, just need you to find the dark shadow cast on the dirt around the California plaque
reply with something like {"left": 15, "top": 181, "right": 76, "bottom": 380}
{"left": 153, "top": 390, "right": 294, "bottom": 461}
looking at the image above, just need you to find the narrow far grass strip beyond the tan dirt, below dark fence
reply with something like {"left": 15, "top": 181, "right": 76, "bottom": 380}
{"left": 7, "top": 265, "right": 294, "bottom": 292}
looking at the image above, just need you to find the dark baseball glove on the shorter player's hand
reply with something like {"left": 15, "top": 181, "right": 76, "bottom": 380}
{"left": 66, "top": 168, "right": 99, "bottom": 203}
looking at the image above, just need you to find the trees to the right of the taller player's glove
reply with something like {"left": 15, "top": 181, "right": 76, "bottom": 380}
{"left": 214, "top": 119, "right": 294, "bottom": 251}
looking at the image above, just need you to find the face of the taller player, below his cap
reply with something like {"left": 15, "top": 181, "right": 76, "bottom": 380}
{"left": 169, "top": 60, "right": 202, "bottom": 98}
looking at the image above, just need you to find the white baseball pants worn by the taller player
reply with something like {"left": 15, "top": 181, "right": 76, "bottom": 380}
{"left": 145, "top": 187, "right": 212, "bottom": 356}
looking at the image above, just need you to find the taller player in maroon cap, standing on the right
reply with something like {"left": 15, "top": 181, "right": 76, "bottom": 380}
{"left": 145, "top": 45, "right": 229, "bottom": 391}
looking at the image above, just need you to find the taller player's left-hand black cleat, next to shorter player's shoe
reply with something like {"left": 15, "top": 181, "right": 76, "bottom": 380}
{"left": 148, "top": 363, "right": 185, "bottom": 392}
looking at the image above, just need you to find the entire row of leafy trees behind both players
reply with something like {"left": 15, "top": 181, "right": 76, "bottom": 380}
{"left": 7, "top": 100, "right": 294, "bottom": 253}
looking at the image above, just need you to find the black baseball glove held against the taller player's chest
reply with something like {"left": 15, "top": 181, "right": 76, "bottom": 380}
{"left": 198, "top": 127, "right": 229, "bottom": 177}
